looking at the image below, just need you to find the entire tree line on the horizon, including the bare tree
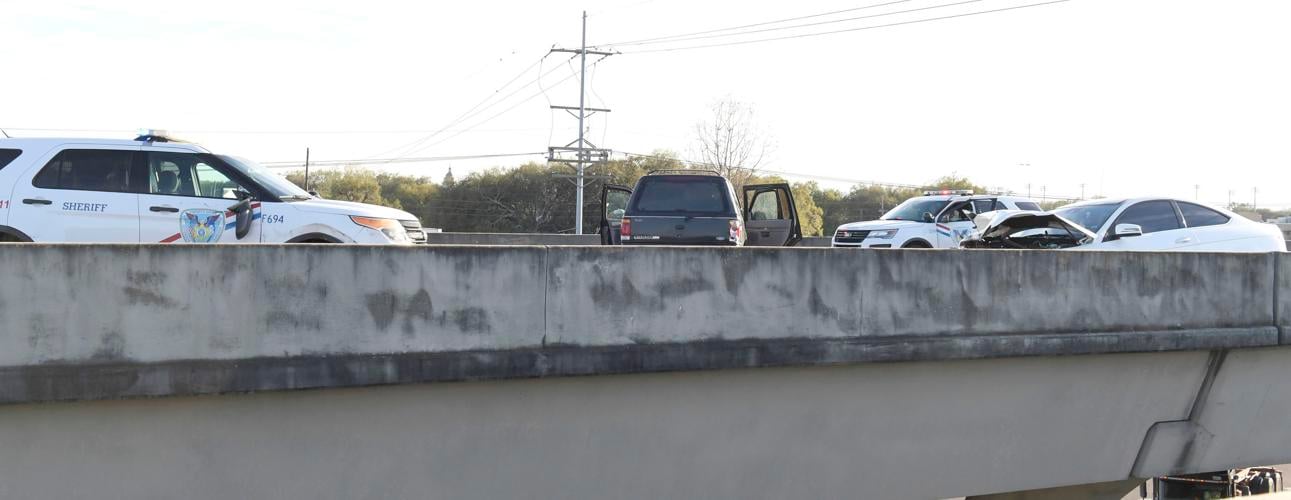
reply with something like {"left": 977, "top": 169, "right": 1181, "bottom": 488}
{"left": 277, "top": 98, "right": 1286, "bottom": 236}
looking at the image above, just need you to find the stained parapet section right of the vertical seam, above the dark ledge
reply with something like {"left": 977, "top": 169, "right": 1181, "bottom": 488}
{"left": 547, "top": 248, "right": 1274, "bottom": 345}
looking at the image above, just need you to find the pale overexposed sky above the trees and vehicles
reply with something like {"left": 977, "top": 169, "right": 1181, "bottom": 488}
{"left": 0, "top": 0, "right": 1291, "bottom": 208}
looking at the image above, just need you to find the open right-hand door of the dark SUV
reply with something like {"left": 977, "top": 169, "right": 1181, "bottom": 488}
{"left": 744, "top": 183, "right": 803, "bottom": 247}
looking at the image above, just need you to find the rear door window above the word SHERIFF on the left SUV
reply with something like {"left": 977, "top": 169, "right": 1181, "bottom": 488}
{"left": 31, "top": 150, "right": 134, "bottom": 193}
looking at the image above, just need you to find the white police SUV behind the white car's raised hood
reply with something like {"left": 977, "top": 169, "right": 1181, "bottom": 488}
{"left": 833, "top": 190, "right": 1041, "bottom": 248}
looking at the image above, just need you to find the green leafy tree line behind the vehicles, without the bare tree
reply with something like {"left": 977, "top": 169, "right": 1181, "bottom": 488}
{"left": 287, "top": 152, "right": 1057, "bottom": 236}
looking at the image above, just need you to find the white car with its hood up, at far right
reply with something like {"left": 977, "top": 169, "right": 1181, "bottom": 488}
{"left": 962, "top": 198, "right": 1286, "bottom": 252}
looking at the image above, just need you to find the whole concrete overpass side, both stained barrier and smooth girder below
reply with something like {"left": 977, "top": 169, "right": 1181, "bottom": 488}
{"left": 0, "top": 245, "right": 1291, "bottom": 499}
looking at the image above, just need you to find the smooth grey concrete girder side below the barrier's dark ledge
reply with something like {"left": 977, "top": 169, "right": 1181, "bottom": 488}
{"left": 0, "top": 353, "right": 1206, "bottom": 500}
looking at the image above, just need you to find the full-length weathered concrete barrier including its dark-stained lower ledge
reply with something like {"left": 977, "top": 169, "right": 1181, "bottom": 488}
{"left": 0, "top": 245, "right": 1291, "bottom": 402}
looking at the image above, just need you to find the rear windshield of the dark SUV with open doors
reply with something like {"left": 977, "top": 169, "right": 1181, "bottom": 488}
{"left": 629, "top": 176, "right": 735, "bottom": 216}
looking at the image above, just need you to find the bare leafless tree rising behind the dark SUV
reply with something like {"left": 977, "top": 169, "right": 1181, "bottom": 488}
{"left": 695, "top": 98, "right": 772, "bottom": 187}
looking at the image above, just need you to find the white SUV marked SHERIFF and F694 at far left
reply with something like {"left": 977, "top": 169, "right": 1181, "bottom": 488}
{"left": 0, "top": 130, "right": 426, "bottom": 244}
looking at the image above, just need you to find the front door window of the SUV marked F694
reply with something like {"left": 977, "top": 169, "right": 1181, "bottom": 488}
{"left": 148, "top": 152, "right": 245, "bottom": 199}
